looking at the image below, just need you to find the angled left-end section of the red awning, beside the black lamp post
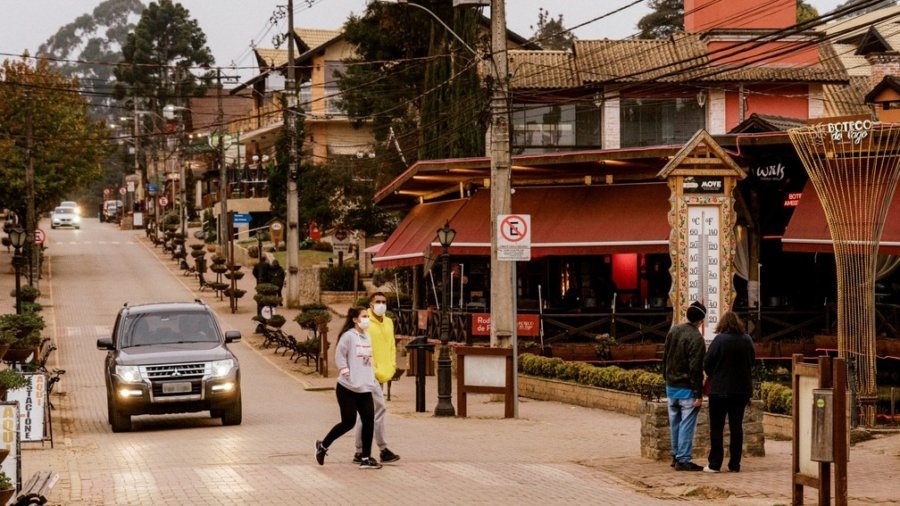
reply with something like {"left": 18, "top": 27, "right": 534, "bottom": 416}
{"left": 372, "top": 199, "right": 467, "bottom": 269}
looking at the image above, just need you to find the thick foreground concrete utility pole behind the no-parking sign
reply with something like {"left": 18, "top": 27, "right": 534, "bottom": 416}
{"left": 489, "top": 0, "right": 516, "bottom": 346}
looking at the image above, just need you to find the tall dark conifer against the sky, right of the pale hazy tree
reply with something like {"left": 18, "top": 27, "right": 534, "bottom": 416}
{"left": 114, "top": 0, "right": 215, "bottom": 113}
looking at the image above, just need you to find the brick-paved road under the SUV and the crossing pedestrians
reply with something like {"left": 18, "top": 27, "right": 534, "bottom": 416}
{"left": 15, "top": 220, "right": 683, "bottom": 505}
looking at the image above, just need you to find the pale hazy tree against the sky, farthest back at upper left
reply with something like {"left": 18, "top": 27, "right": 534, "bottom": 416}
{"left": 38, "top": 0, "right": 144, "bottom": 121}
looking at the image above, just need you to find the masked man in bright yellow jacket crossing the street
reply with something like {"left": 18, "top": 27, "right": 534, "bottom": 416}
{"left": 353, "top": 292, "right": 400, "bottom": 463}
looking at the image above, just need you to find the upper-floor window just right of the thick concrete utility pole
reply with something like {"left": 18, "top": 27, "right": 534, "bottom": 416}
{"left": 512, "top": 103, "right": 600, "bottom": 154}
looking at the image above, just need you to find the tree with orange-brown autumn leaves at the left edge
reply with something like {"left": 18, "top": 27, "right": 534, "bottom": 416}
{"left": 0, "top": 58, "right": 110, "bottom": 216}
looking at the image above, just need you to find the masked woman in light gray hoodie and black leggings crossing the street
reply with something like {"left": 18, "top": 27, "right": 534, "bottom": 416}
{"left": 316, "top": 307, "right": 381, "bottom": 469}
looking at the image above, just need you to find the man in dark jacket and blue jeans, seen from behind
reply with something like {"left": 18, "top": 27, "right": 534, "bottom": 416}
{"left": 663, "top": 301, "right": 706, "bottom": 471}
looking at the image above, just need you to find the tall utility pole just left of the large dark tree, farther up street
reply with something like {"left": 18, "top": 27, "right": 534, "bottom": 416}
{"left": 284, "top": 0, "right": 300, "bottom": 308}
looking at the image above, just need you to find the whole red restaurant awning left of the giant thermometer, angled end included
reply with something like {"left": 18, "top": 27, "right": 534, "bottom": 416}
{"left": 373, "top": 183, "right": 670, "bottom": 268}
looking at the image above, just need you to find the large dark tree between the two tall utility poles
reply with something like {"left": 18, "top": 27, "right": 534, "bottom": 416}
{"left": 339, "top": 0, "right": 487, "bottom": 167}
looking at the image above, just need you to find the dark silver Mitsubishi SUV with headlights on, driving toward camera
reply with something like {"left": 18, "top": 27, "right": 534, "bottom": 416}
{"left": 97, "top": 300, "right": 241, "bottom": 432}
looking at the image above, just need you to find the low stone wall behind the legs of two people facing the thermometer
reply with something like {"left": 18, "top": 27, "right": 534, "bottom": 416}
{"left": 640, "top": 400, "right": 766, "bottom": 462}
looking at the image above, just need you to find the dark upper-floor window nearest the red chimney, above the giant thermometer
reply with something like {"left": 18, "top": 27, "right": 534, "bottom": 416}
{"left": 619, "top": 97, "right": 706, "bottom": 148}
